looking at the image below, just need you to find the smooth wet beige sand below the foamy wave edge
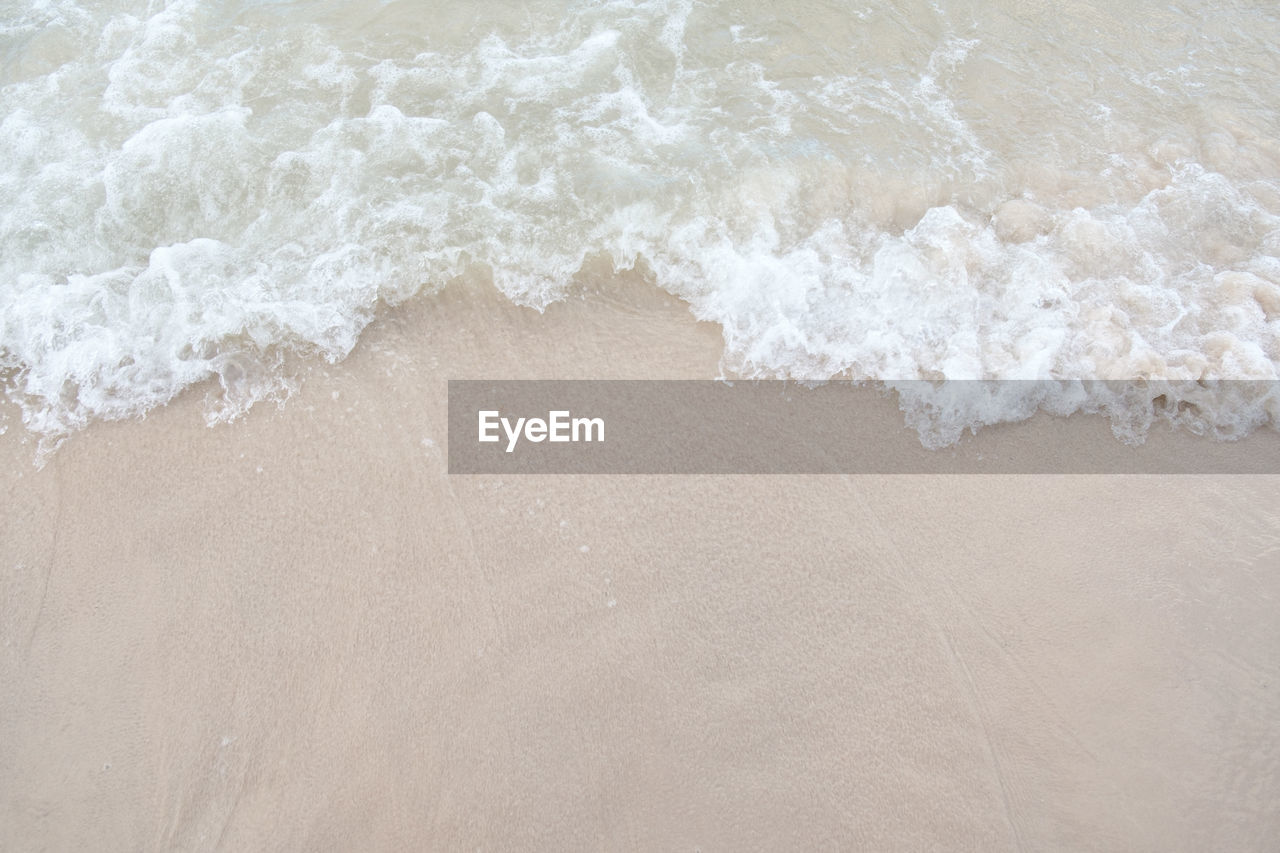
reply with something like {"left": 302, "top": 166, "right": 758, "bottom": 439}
{"left": 0, "top": 282, "right": 1280, "bottom": 852}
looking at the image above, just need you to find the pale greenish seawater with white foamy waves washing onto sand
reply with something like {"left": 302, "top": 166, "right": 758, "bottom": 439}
{"left": 0, "top": 0, "right": 1280, "bottom": 435}
